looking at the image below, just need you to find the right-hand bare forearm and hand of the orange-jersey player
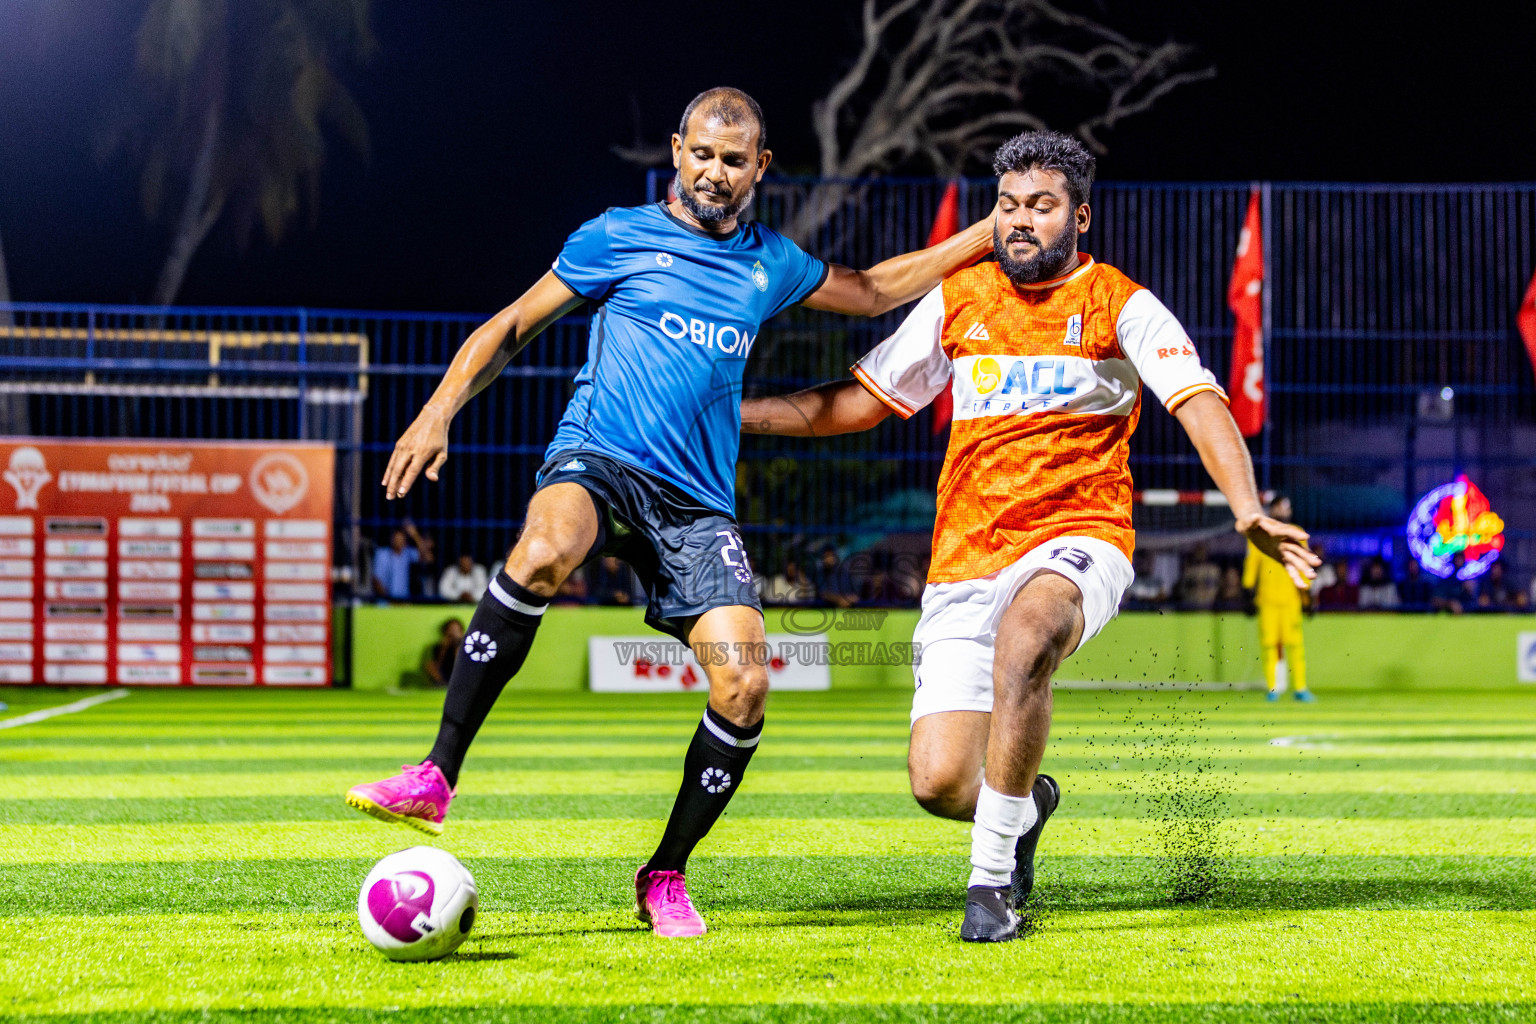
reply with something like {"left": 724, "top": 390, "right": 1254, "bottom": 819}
{"left": 1174, "top": 391, "right": 1322, "bottom": 588}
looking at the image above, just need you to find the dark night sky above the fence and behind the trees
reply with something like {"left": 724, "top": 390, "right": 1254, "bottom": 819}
{"left": 0, "top": 0, "right": 1536, "bottom": 312}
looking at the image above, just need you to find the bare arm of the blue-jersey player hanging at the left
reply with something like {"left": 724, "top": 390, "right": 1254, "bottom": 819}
{"left": 382, "top": 273, "right": 582, "bottom": 499}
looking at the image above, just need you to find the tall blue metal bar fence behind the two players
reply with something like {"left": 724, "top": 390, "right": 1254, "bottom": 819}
{"left": 0, "top": 178, "right": 1536, "bottom": 589}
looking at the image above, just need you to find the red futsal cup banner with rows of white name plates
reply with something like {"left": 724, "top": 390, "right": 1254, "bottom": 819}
{"left": 0, "top": 438, "right": 336, "bottom": 686}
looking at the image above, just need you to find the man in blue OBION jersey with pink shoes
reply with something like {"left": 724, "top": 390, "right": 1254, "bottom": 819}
{"left": 347, "top": 89, "right": 992, "bottom": 936}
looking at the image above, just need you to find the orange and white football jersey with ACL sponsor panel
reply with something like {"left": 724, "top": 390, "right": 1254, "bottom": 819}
{"left": 852, "top": 253, "right": 1227, "bottom": 583}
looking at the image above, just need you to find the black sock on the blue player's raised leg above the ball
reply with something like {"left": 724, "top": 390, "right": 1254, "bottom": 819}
{"left": 427, "top": 573, "right": 550, "bottom": 786}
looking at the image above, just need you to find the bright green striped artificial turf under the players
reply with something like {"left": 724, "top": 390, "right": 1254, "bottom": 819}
{"left": 0, "top": 688, "right": 1536, "bottom": 1024}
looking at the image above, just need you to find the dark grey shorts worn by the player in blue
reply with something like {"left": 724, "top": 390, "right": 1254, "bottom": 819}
{"left": 535, "top": 448, "right": 762, "bottom": 643}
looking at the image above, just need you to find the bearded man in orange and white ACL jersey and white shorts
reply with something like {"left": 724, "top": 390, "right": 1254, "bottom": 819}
{"left": 742, "top": 132, "right": 1318, "bottom": 941}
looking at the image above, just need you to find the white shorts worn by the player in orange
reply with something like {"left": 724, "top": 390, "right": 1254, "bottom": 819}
{"left": 912, "top": 537, "right": 1135, "bottom": 722}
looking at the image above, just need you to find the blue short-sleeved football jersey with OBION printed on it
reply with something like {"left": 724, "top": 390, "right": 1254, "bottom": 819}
{"left": 548, "top": 203, "right": 826, "bottom": 514}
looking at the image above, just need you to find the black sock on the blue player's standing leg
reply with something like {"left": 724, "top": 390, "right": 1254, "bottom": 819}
{"left": 647, "top": 708, "right": 763, "bottom": 870}
